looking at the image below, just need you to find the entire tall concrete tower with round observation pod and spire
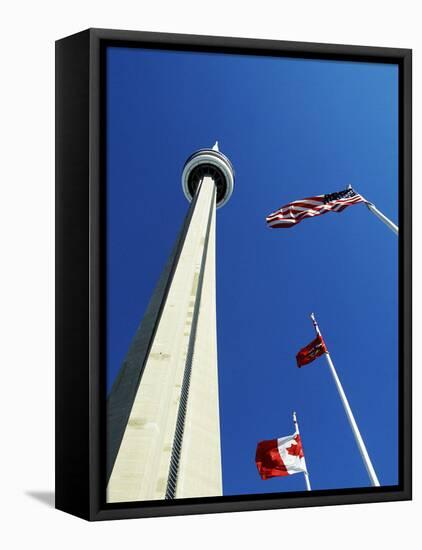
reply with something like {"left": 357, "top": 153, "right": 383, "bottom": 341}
{"left": 107, "top": 143, "right": 234, "bottom": 503}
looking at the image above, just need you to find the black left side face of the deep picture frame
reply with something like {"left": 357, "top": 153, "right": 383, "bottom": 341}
{"left": 55, "top": 31, "right": 89, "bottom": 519}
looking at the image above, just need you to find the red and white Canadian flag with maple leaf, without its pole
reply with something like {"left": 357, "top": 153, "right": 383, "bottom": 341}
{"left": 255, "top": 433, "right": 307, "bottom": 479}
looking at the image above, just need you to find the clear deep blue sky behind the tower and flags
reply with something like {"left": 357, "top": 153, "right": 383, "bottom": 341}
{"left": 107, "top": 47, "right": 400, "bottom": 495}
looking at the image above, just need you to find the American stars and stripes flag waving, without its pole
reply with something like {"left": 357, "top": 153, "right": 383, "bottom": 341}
{"left": 267, "top": 187, "right": 366, "bottom": 228}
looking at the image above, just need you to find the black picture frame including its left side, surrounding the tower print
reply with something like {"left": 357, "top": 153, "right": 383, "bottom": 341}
{"left": 56, "top": 29, "right": 412, "bottom": 520}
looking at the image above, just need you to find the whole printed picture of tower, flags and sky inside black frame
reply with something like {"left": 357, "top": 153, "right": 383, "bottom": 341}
{"left": 104, "top": 46, "right": 400, "bottom": 503}
